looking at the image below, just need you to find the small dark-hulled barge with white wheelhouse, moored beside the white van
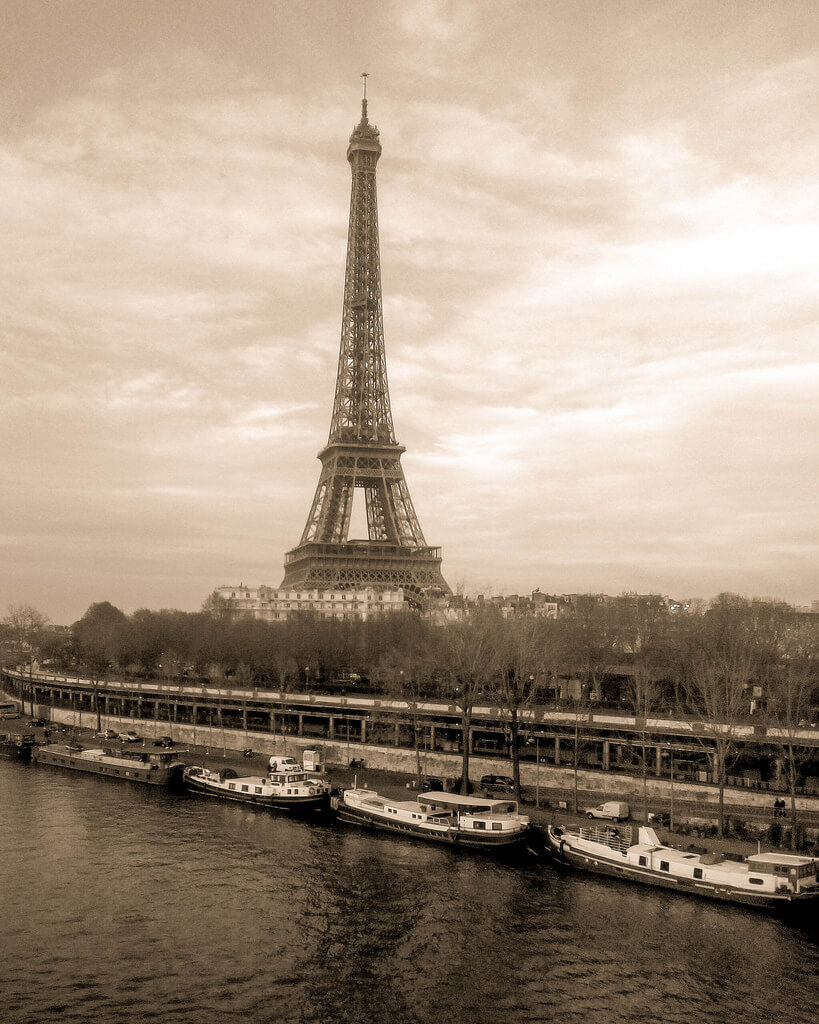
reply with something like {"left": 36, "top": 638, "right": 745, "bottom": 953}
{"left": 182, "top": 757, "right": 330, "bottom": 810}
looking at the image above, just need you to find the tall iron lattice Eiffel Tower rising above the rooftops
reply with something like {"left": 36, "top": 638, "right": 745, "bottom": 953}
{"left": 282, "top": 81, "right": 449, "bottom": 593}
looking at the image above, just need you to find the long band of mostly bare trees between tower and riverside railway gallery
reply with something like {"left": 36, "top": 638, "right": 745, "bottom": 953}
{"left": 3, "top": 594, "right": 819, "bottom": 833}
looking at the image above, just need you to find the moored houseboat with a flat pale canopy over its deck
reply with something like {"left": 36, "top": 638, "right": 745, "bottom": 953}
{"left": 331, "top": 788, "right": 529, "bottom": 851}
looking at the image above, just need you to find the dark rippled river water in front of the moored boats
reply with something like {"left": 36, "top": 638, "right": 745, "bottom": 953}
{"left": 0, "top": 761, "right": 819, "bottom": 1024}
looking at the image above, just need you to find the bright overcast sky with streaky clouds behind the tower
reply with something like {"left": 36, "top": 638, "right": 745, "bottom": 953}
{"left": 0, "top": 0, "right": 819, "bottom": 623}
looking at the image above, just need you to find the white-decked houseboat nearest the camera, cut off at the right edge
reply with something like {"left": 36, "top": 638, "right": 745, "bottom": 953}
{"left": 547, "top": 824, "right": 819, "bottom": 907}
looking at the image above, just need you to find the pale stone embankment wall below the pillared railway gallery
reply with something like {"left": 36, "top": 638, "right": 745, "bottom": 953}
{"left": 38, "top": 707, "right": 819, "bottom": 813}
